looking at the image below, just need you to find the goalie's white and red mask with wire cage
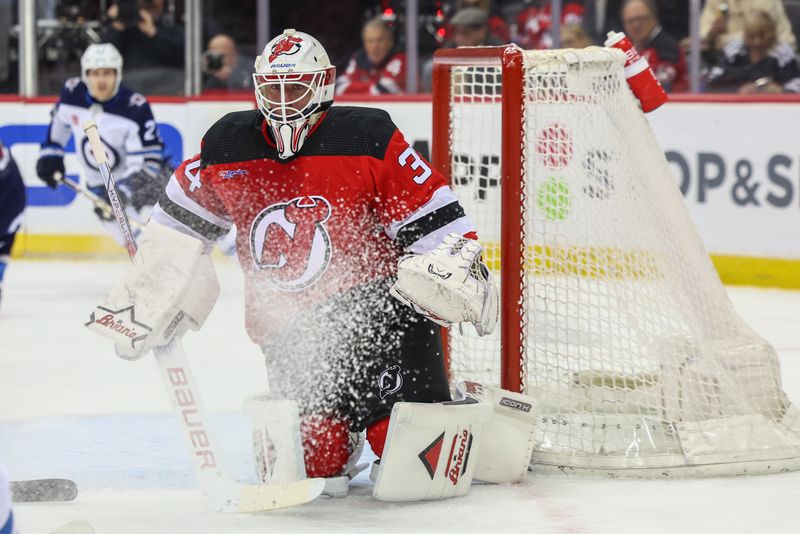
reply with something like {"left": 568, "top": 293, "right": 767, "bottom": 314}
{"left": 253, "top": 29, "right": 336, "bottom": 159}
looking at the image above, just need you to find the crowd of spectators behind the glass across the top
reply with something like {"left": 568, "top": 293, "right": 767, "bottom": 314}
{"left": 0, "top": 0, "right": 800, "bottom": 95}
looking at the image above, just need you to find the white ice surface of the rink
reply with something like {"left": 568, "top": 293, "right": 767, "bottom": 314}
{"left": 0, "top": 260, "right": 800, "bottom": 534}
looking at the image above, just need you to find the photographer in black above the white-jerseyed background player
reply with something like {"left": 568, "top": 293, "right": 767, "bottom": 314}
{"left": 103, "top": 0, "right": 184, "bottom": 93}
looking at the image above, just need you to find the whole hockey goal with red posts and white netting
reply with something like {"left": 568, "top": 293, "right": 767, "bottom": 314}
{"left": 432, "top": 45, "right": 800, "bottom": 477}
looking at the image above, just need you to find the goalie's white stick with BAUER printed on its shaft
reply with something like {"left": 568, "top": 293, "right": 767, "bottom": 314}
{"left": 83, "top": 121, "right": 325, "bottom": 512}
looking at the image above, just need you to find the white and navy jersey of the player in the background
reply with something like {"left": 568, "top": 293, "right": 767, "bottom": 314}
{"left": 40, "top": 78, "right": 163, "bottom": 187}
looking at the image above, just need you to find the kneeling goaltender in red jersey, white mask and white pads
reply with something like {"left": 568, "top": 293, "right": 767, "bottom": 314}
{"left": 89, "top": 30, "right": 537, "bottom": 506}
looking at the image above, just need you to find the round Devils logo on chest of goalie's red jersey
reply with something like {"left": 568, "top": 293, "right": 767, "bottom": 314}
{"left": 250, "top": 196, "right": 333, "bottom": 291}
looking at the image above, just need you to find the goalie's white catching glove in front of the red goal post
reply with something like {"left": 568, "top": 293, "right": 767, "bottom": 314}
{"left": 389, "top": 234, "right": 499, "bottom": 336}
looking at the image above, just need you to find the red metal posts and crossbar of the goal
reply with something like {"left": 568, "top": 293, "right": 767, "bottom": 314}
{"left": 431, "top": 45, "right": 525, "bottom": 391}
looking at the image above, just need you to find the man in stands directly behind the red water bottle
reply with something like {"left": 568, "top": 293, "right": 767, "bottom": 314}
{"left": 622, "top": 0, "right": 688, "bottom": 92}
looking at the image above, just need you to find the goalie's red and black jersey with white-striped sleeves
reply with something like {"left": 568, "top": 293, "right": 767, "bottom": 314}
{"left": 152, "top": 106, "right": 474, "bottom": 344}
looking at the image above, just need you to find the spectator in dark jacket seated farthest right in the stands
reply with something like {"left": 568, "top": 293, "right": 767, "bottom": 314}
{"left": 708, "top": 11, "right": 800, "bottom": 94}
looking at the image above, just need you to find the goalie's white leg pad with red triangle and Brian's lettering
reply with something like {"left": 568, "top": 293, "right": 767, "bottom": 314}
{"left": 373, "top": 402, "right": 492, "bottom": 501}
